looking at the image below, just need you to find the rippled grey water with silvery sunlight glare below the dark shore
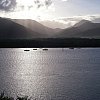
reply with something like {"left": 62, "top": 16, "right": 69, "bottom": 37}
{"left": 0, "top": 48, "right": 100, "bottom": 100}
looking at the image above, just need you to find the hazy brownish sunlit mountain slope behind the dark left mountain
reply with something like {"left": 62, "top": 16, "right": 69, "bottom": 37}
{"left": 11, "top": 19, "right": 58, "bottom": 36}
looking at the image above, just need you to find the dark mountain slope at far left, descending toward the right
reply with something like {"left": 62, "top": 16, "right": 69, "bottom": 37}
{"left": 0, "top": 18, "right": 44, "bottom": 39}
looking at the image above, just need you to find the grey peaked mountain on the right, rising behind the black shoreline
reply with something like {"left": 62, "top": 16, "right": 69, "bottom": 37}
{"left": 54, "top": 20, "right": 100, "bottom": 38}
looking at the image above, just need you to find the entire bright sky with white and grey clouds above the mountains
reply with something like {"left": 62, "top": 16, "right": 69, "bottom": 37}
{"left": 0, "top": 0, "right": 100, "bottom": 28}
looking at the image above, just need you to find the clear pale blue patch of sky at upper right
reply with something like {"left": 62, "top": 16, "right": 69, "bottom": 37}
{"left": 55, "top": 0, "right": 100, "bottom": 17}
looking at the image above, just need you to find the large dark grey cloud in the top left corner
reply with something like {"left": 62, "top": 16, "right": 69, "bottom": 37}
{"left": 0, "top": 0, "right": 16, "bottom": 11}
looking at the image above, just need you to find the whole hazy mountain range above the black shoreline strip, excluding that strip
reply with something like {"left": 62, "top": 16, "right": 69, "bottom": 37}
{"left": 0, "top": 18, "right": 100, "bottom": 39}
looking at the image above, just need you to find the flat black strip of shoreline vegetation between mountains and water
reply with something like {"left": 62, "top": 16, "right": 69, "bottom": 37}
{"left": 0, "top": 38, "right": 100, "bottom": 48}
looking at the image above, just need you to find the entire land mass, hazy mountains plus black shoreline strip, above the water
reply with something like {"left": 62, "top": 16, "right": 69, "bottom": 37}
{"left": 0, "top": 18, "right": 100, "bottom": 48}
